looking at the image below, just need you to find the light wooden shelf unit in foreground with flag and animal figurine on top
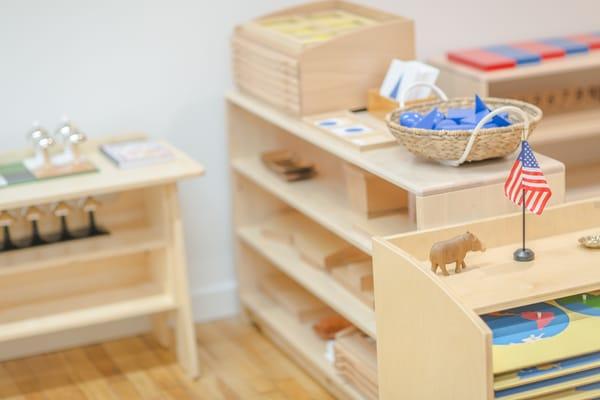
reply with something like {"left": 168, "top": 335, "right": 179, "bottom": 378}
{"left": 373, "top": 198, "right": 600, "bottom": 400}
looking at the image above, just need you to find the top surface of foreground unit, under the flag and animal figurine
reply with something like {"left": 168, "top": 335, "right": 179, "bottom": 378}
{"left": 422, "top": 229, "right": 600, "bottom": 314}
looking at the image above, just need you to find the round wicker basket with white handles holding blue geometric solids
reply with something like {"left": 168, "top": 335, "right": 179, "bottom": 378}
{"left": 386, "top": 88, "right": 542, "bottom": 166}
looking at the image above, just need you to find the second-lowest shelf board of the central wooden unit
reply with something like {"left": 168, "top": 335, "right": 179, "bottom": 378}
{"left": 237, "top": 227, "right": 375, "bottom": 338}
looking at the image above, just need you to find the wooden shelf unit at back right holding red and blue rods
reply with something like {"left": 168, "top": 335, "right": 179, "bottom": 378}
{"left": 431, "top": 52, "right": 600, "bottom": 201}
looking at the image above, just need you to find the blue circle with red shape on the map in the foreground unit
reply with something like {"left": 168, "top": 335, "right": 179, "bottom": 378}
{"left": 482, "top": 303, "right": 569, "bottom": 345}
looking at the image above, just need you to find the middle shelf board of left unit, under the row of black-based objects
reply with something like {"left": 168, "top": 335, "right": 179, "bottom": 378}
{"left": 0, "top": 228, "right": 166, "bottom": 277}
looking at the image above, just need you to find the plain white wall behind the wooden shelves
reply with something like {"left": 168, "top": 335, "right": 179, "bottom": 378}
{"left": 0, "top": 0, "right": 600, "bottom": 320}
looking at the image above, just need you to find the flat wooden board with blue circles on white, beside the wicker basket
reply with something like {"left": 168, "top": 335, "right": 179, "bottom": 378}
{"left": 304, "top": 110, "right": 397, "bottom": 151}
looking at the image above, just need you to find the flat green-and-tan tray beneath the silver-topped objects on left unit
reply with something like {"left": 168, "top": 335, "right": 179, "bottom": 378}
{"left": 0, "top": 160, "right": 98, "bottom": 189}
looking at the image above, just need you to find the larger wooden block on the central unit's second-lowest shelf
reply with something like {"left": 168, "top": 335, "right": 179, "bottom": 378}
{"left": 294, "top": 221, "right": 370, "bottom": 270}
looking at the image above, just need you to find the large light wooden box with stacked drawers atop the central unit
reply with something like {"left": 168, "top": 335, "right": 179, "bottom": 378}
{"left": 232, "top": 1, "right": 415, "bottom": 115}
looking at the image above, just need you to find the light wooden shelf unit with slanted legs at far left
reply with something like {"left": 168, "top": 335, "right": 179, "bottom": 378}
{"left": 0, "top": 135, "right": 203, "bottom": 377}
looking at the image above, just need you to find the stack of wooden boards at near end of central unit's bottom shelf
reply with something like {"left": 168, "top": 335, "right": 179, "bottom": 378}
{"left": 334, "top": 328, "right": 379, "bottom": 400}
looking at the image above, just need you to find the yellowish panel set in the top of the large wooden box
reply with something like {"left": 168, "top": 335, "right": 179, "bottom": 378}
{"left": 258, "top": 10, "right": 375, "bottom": 44}
